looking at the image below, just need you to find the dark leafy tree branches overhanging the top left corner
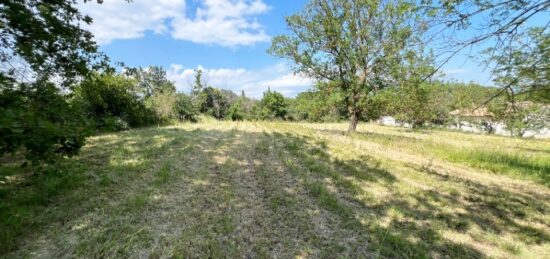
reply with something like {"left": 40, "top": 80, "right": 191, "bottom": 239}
{"left": 0, "top": 0, "right": 107, "bottom": 86}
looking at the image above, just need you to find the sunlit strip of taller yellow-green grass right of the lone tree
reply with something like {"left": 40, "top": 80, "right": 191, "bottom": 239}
{"left": 344, "top": 125, "right": 550, "bottom": 186}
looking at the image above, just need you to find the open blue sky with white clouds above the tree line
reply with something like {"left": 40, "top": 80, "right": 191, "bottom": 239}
{"left": 80, "top": 0, "right": 498, "bottom": 97}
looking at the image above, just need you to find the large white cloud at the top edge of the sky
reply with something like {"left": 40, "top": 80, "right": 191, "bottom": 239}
{"left": 79, "top": 0, "right": 269, "bottom": 47}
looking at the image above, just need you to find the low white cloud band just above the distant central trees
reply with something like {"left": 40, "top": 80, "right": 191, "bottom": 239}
{"left": 168, "top": 64, "right": 315, "bottom": 98}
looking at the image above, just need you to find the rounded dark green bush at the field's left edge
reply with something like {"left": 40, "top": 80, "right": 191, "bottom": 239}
{"left": 75, "top": 73, "right": 159, "bottom": 130}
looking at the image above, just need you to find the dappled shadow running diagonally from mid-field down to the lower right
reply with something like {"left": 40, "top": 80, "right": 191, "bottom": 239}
{"left": 274, "top": 134, "right": 488, "bottom": 258}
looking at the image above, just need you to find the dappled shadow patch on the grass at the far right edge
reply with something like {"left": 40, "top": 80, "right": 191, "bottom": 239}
{"left": 416, "top": 168, "right": 550, "bottom": 244}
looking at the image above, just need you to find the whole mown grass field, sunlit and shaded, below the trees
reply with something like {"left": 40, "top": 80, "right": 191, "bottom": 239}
{"left": 0, "top": 120, "right": 550, "bottom": 258}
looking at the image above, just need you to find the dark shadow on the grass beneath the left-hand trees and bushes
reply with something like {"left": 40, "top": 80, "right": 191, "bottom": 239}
{"left": 0, "top": 129, "right": 212, "bottom": 257}
